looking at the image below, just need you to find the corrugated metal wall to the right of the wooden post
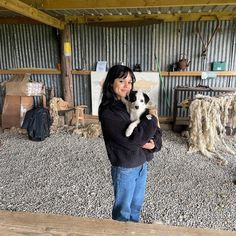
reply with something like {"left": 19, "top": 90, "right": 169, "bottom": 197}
{"left": 71, "top": 21, "right": 236, "bottom": 116}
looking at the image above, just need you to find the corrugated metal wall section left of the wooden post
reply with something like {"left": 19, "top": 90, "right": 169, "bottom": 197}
{"left": 0, "top": 24, "right": 62, "bottom": 109}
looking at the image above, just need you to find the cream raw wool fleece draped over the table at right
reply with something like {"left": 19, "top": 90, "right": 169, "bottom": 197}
{"left": 189, "top": 93, "right": 236, "bottom": 165}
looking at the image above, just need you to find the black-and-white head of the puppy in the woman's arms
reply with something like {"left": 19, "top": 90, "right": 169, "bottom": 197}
{"left": 129, "top": 91, "right": 150, "bottom": 110}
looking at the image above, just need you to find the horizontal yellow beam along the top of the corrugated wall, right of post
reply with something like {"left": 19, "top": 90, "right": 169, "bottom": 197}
{"left": 65, "top": 11, "right": 236, "bottom": 23}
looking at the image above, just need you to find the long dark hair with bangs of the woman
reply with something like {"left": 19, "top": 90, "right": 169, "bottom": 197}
{"left": 98, "top": 65, "right": 136, "bottom": 116}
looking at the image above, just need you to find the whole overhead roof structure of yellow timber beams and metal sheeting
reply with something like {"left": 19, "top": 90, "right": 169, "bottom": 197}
{"left": 0, "top": 0, "right": 236, "bottom": 30}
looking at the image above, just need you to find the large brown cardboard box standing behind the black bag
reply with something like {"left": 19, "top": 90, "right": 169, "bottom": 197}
{"left": 2, "top": 95, "right": 34, "bottom": 129}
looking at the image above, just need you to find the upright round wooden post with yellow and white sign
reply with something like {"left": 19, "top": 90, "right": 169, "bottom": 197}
{"left": 61, "top": 25, "right": 74, "bottom": 106}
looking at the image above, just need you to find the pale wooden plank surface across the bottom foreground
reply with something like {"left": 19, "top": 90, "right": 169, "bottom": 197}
{"left": 0, "top": 211, "right": 236, "bottom": 236}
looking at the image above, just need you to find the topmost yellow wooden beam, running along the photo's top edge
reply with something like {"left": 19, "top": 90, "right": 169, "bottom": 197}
{"left": 42, "top": 0, "right": 236, "bottom": 10}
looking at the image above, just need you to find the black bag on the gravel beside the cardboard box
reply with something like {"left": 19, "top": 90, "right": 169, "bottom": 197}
{"left": 22, "top": 107, "right": 52, "bottom": 141}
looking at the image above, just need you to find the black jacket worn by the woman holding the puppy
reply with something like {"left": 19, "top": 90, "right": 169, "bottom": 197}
{"left": 99, "top": 101, "right": 157, "bottom": 168}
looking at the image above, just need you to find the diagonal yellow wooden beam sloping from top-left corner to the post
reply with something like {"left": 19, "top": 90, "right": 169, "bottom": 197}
{"left": 0, "top": 0, "right": 65, "bottom": 29}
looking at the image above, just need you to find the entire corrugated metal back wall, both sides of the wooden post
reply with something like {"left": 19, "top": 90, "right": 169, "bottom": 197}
{"left": 0, "top": 21, "right": 236, "bottom": 116}
